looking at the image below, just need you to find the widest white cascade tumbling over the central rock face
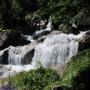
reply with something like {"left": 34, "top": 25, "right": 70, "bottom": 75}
{"left": 32, "top": 33, "right": 78, "bottom": 67}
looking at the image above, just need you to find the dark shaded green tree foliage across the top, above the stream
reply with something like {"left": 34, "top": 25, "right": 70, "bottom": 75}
{"left": 0, "top": 0, "right": 90, "bottom": 29}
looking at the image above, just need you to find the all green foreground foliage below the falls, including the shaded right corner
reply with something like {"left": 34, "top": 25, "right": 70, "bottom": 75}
{"left": 6, "top": 49, "right": 90, "bottom": 90}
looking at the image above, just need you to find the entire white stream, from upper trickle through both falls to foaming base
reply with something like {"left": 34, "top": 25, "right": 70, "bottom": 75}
{"left": 0, "top": 21, "right": 85, "bottom": 77}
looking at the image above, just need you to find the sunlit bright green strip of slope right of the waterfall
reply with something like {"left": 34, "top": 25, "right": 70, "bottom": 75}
{"left": 62, "top": 50, "right": 90, "bottom": 86}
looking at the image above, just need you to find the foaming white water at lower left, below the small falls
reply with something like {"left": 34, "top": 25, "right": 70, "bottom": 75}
{"left": 0, "top": 64, "right": 35, "bottom": 78}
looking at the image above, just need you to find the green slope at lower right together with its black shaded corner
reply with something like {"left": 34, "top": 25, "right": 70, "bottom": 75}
{"left": 44, "top": 50, "right": 90, "bottom": 90}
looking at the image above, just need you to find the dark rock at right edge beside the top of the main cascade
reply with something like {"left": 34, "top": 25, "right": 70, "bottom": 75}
{"left": 79, "top": 30, "right": 90, "bottom": 51}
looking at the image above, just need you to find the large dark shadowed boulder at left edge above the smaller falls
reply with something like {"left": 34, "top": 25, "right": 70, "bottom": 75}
{"left": 0, "top": 31, "right": 30, "bottom": 50}
